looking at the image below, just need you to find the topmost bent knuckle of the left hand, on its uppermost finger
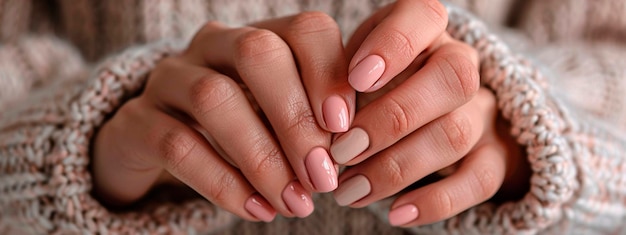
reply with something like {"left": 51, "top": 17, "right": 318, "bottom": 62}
{"left": 287, "top": 11, "right": 340, "bottom": 37}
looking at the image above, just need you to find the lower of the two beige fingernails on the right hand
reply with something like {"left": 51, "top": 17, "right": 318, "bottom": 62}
{"left": 333, "top": 175, "right": 372, "bottom": 206}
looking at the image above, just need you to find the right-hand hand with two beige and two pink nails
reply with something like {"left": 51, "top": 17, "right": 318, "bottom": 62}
{"left": 331, "top": 0, "right": 519, "bottom": 226}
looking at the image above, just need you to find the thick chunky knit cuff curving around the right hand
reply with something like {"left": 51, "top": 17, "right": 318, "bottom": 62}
{"left": 402, "top": 6, "right": 578, "bottom": 234}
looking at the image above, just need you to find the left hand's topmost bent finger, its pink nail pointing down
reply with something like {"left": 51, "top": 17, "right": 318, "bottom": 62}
{"left": 254, "top": 12, "right": 355, "bottom": 132}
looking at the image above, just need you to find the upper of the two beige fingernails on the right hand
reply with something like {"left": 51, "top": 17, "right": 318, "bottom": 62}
{"left": 330, "top": 128, "right": 370, "bottom": 164}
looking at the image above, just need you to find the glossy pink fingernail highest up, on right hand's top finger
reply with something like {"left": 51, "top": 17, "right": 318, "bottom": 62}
{"left": 348, "top": 55, "right": 385, "bottom": 92}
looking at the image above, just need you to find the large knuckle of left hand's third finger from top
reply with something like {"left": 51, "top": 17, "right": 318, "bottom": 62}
{"left": 189, "top": 75, "right": 240, "bottom": 116}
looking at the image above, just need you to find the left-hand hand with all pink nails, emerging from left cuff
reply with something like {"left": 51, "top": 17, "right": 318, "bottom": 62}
{"left": 93, "top": 12, "right": 355, "bottom": 221}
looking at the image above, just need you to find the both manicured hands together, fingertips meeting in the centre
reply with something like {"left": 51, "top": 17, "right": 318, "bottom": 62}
{"left": 93, "top": 0, "right": 510, "bottom": 226}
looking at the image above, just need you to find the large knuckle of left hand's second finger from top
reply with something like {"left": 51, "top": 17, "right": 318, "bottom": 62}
{"left": 235, "top": 29, "right": 291, "bottom": 66}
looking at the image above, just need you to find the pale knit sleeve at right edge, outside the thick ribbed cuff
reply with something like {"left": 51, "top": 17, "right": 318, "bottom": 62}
{"left": 533, "top": 41, "right": 626, "bottom": 234}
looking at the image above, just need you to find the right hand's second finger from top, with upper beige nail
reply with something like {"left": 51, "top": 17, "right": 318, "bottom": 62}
{"left": 330, "top": 42, "right": 479, "bottom": 165}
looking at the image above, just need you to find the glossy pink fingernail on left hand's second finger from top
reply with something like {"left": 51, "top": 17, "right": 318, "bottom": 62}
{"left": 305, "top": 147, "right": 337, "bottom": 193}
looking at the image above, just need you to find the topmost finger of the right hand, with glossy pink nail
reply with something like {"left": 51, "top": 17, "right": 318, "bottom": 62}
{"left": 348, "top": 0, "right": 448, "bottom": 92}
